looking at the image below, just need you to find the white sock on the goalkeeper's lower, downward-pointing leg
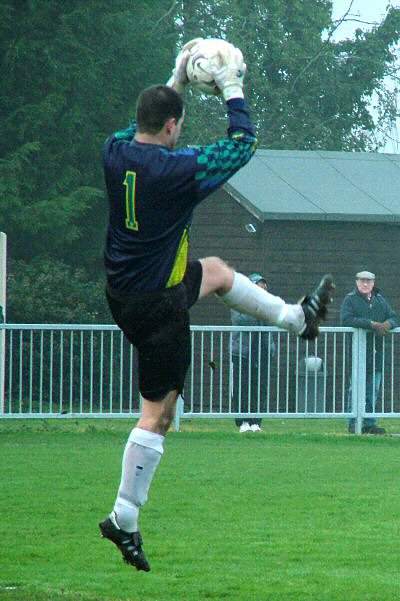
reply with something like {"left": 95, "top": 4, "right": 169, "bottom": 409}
{"left": 110, "top": 428, "right": 164, "bottom": 532}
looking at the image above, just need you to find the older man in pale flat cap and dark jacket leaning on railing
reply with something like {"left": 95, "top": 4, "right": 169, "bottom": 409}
{"left": 340, "top": 271, "right": 399, "bottom": 434}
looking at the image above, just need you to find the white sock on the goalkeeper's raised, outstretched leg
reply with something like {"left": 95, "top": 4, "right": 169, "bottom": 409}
{"left": 220, "top": 272, "right": 304, "bottom": 334}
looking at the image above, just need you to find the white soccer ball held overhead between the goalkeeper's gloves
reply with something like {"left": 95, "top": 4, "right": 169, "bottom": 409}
{"left": 186, "top": 38, "right": 234, "bottom": 94}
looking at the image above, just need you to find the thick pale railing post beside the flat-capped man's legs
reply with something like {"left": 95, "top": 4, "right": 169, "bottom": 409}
{"left": 351, "top": 328, "right": 367, "bottom": 434}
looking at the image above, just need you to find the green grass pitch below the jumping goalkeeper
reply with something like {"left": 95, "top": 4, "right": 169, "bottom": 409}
{"left": 0, "top": 419, "right": 400, "bottom": 601}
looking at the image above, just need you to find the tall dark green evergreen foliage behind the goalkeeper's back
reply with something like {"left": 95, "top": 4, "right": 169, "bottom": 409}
{"left": 0, "top": 0, "right": 176, "bottom": 322}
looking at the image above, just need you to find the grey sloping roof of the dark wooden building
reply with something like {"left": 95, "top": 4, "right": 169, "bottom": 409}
{"left": 225, "top": 149, "right": 400, "bottom": 222}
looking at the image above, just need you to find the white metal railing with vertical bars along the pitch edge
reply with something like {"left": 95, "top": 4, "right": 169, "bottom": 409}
{"left": 0, "top": 324, "right": 400, "bottom": 432}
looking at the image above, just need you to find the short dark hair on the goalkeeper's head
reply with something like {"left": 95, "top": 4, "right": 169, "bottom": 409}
{"left": 136, "top": 85, "right": 183, "bottom": 135}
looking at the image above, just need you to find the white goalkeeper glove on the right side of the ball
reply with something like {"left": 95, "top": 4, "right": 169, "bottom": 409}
{"left": 213, "top": 47, "right": 247, "bottom": 101}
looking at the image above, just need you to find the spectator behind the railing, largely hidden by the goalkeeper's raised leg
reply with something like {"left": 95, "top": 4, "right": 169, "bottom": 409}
{"left": 231, "top": 273, "right": 275, "bottom": 433}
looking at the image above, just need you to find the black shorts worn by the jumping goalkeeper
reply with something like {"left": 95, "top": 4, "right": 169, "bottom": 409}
{"left": 106, "top": 261, "right": 203, "bottom": 401}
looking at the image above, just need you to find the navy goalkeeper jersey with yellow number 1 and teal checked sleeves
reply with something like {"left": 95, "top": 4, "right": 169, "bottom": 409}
{"left": 103, "top": 98, "right": 256, "bottom": 294}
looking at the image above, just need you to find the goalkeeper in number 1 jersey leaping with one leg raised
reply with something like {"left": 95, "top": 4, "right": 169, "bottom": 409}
{"left": 99, "top": 40, "right": 333, "bottom": 571}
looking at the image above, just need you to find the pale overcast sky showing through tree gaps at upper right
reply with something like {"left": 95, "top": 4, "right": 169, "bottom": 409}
{"left": 332, "top": 0, "right": 400, "bottom": 154}
